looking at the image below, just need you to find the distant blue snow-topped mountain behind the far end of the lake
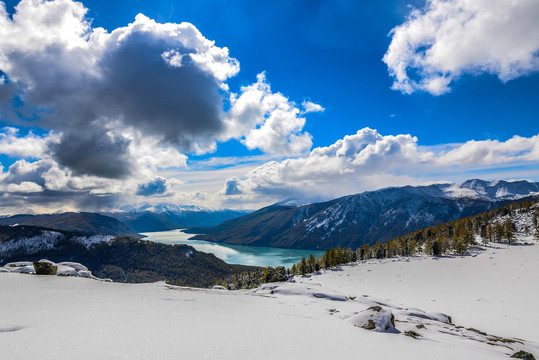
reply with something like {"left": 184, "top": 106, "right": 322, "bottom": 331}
{"left": 106, "top": 203, "right": 251, "bottom": 233}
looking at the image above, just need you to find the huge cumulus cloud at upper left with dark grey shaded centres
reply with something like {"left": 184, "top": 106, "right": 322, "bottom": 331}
{"left": 0, "top": 0, "right": 239, "bottom": 178}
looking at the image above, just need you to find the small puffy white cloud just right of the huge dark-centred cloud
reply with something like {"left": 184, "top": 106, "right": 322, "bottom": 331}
{"left": 223, "top": 73, "right": 312, "bottom": 155}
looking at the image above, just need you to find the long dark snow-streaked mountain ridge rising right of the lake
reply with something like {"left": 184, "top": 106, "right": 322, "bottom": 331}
{"left": 191, "top": 179, "right": 539, "bottom": 249}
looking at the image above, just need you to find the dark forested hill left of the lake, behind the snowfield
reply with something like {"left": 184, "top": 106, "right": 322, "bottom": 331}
{"left": 0, "top": 226, "right": 257, "bottom": 287}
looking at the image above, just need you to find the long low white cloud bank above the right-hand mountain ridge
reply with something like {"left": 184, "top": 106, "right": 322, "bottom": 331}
{"left": 221, "top": 128, "right": 539, "bottom": 200}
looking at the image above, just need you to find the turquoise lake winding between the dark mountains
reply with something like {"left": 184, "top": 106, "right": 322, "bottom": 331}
{"left": 142, "top": 230, "right": 324, "bottom": 268}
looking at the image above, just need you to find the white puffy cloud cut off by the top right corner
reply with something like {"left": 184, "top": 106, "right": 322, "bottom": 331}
{"left": 383, "top": 0, "right": 539, "bottom": 95}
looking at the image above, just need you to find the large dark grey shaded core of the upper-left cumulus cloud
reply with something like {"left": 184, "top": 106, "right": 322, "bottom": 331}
{"left": 97, "top": 32, "right": 223, "bottom": 151}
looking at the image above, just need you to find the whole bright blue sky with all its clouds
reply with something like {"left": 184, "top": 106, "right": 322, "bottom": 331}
{"left": 0, "top": 0, "right": 539, "bottom": 214}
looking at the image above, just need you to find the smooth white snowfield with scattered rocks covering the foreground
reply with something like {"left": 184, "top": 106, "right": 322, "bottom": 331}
{"left": 0, "top": 245, "right": 539, "bottom": 359}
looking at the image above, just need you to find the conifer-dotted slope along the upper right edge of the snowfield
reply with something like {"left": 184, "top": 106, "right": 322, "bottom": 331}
{"left": 218, "top": 199, "right": 539, "bottom": 290}
